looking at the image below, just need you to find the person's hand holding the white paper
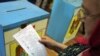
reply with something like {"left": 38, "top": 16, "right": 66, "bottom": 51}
{"left": 40, "top": 36, "right": 66, "bottom": 52}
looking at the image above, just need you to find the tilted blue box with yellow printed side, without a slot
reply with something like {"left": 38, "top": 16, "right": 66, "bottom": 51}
{"left": 46, "top": 0, "right": 82, "bottom": 43}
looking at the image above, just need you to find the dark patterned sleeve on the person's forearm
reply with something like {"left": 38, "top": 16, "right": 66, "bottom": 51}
{"left": 59, "top": 43, "right": 88, "bottom": 56}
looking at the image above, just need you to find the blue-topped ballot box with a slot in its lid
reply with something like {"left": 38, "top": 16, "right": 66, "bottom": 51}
{"left": 0, "top": 1, "right": 49, "bottom": 56}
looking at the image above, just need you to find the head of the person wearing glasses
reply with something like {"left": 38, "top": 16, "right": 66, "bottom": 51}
{"left": 83, "top": 0, "right": 100, "bottom": 37}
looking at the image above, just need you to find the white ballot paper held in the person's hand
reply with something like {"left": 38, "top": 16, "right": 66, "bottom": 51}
{"left": 13, "top": 25, "right": 47, "bottom": 56}
